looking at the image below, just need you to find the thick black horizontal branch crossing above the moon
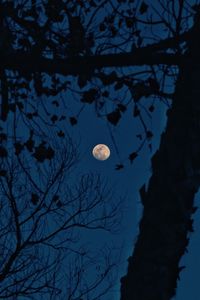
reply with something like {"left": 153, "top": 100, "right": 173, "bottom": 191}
{"left": 0, "top": 48, "right": 183, "bottom": 75}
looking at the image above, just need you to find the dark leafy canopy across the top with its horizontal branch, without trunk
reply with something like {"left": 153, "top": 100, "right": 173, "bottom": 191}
{"left": 0, "top": 0, "right": 198, "bottom": 165}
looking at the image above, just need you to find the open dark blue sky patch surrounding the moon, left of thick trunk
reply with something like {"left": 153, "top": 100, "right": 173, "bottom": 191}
{"left": 70, "top": 95, "right": 174, "bottom": 300}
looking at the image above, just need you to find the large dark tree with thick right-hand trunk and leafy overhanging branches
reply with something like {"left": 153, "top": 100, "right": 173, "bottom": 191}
{"left": 0, "top": 0, "right": 200, "bottom": 300}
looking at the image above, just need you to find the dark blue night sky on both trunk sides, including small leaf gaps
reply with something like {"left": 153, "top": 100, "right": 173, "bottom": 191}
{"left": 0, "top": 1, "right": 200, "bottom": 300}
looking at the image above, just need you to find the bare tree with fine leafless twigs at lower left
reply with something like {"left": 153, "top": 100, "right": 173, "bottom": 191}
{"left": 0, "top": 123, "right": 119, "bottom": 299}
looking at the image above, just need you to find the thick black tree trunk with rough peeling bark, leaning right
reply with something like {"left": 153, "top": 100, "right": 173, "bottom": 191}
{"left": 121, "top": 18, "right": 200, "bottom": 300}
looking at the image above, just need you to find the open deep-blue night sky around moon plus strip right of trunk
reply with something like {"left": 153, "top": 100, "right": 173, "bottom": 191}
{"left": 70, "top": 94, "right": 200, "bottom": 300}
